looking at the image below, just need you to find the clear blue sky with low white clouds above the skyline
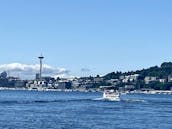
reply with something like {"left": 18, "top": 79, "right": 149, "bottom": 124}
{"left": 0, "top": 0, "right": 172, "bottom": 78}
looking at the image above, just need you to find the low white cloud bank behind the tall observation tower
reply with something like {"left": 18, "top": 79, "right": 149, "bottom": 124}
{"left": 0, "top": 63, "right": 70, "bottom": 79}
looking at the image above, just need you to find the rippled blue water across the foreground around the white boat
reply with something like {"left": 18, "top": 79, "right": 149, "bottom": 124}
{"left": 0, "top": 91, "right": 172, "bottom": 129}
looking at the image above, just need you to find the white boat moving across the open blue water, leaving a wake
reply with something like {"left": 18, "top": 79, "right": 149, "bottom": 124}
{"left": 103, "top": 90, "right": 120, "bottom": 101}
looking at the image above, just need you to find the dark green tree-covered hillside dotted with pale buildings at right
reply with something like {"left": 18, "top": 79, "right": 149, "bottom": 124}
{"left": 103, "top": 62, "right": 172, "bottom": 90}
